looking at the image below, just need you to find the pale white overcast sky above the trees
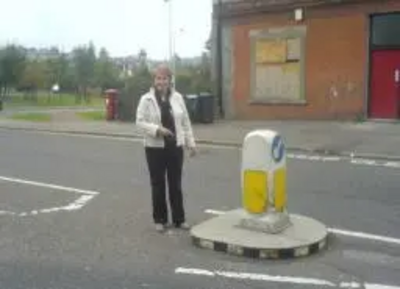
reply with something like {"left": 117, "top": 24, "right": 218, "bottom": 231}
{"left": 0, "top": 0, "right": 212, "bottom": 59}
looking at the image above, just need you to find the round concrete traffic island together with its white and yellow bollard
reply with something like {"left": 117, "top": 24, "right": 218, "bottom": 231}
{"left": 191, "top": 130, "right": 328, "bottom": 259}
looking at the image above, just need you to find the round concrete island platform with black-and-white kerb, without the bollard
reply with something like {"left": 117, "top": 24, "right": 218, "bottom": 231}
{"left": 191, "top": 209, "right": 327, "bottom": 259}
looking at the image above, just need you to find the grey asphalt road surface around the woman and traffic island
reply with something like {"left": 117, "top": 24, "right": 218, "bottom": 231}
{"left": 0, "top": 130, "right": 400, "bottom": 289}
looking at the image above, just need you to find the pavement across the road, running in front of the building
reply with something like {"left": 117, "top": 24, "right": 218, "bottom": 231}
{"left": 0, "top": 109, "right": 400, "bottom": 160}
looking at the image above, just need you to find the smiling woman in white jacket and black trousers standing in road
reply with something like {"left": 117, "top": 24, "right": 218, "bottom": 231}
{"left": 136, "top": 65, "right": 196, "bottom": 232}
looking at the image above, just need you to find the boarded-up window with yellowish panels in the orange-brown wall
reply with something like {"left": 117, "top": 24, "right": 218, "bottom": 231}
{"left": 252, "top": 25, "right": 305, "bottom": 103}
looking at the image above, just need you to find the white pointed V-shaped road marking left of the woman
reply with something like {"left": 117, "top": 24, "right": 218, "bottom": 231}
{"left": 0, "top": 176, "right": 99, "bottom": 217}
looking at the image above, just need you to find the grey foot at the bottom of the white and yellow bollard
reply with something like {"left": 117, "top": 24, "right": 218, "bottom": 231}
{"left": 239, "top": 212, "right": 292, "bottom": 234}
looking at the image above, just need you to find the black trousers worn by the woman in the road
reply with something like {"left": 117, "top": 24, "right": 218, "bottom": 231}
{"left": 145, "top": 145, "right": 185, "bottom": 225}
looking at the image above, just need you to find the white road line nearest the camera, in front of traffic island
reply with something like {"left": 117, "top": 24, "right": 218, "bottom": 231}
{"left": 175, "top": 267, "right": 400, "bottom": 289}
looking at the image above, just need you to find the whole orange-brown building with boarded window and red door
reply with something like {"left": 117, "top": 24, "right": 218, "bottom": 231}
{"left": 212, "top": 0, "right": 400, "bottom": 119}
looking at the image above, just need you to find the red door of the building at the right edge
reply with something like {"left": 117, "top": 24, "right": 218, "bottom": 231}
{"left": 369, "top": 50, "right": 400, "bottom": 119}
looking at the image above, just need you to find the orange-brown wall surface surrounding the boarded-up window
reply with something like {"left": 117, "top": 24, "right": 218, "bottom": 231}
{"left": 231, "top": 1, "right": 400, "bottom": 119}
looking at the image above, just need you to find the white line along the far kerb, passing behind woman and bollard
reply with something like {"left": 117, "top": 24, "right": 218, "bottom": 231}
{"left": 3, "top": 131, "right": 400, "bottom": 169}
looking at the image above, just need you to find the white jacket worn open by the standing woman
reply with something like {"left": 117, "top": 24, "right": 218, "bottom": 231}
{"left": 136, "top": 88, "right": 196, "bottom": 147}
